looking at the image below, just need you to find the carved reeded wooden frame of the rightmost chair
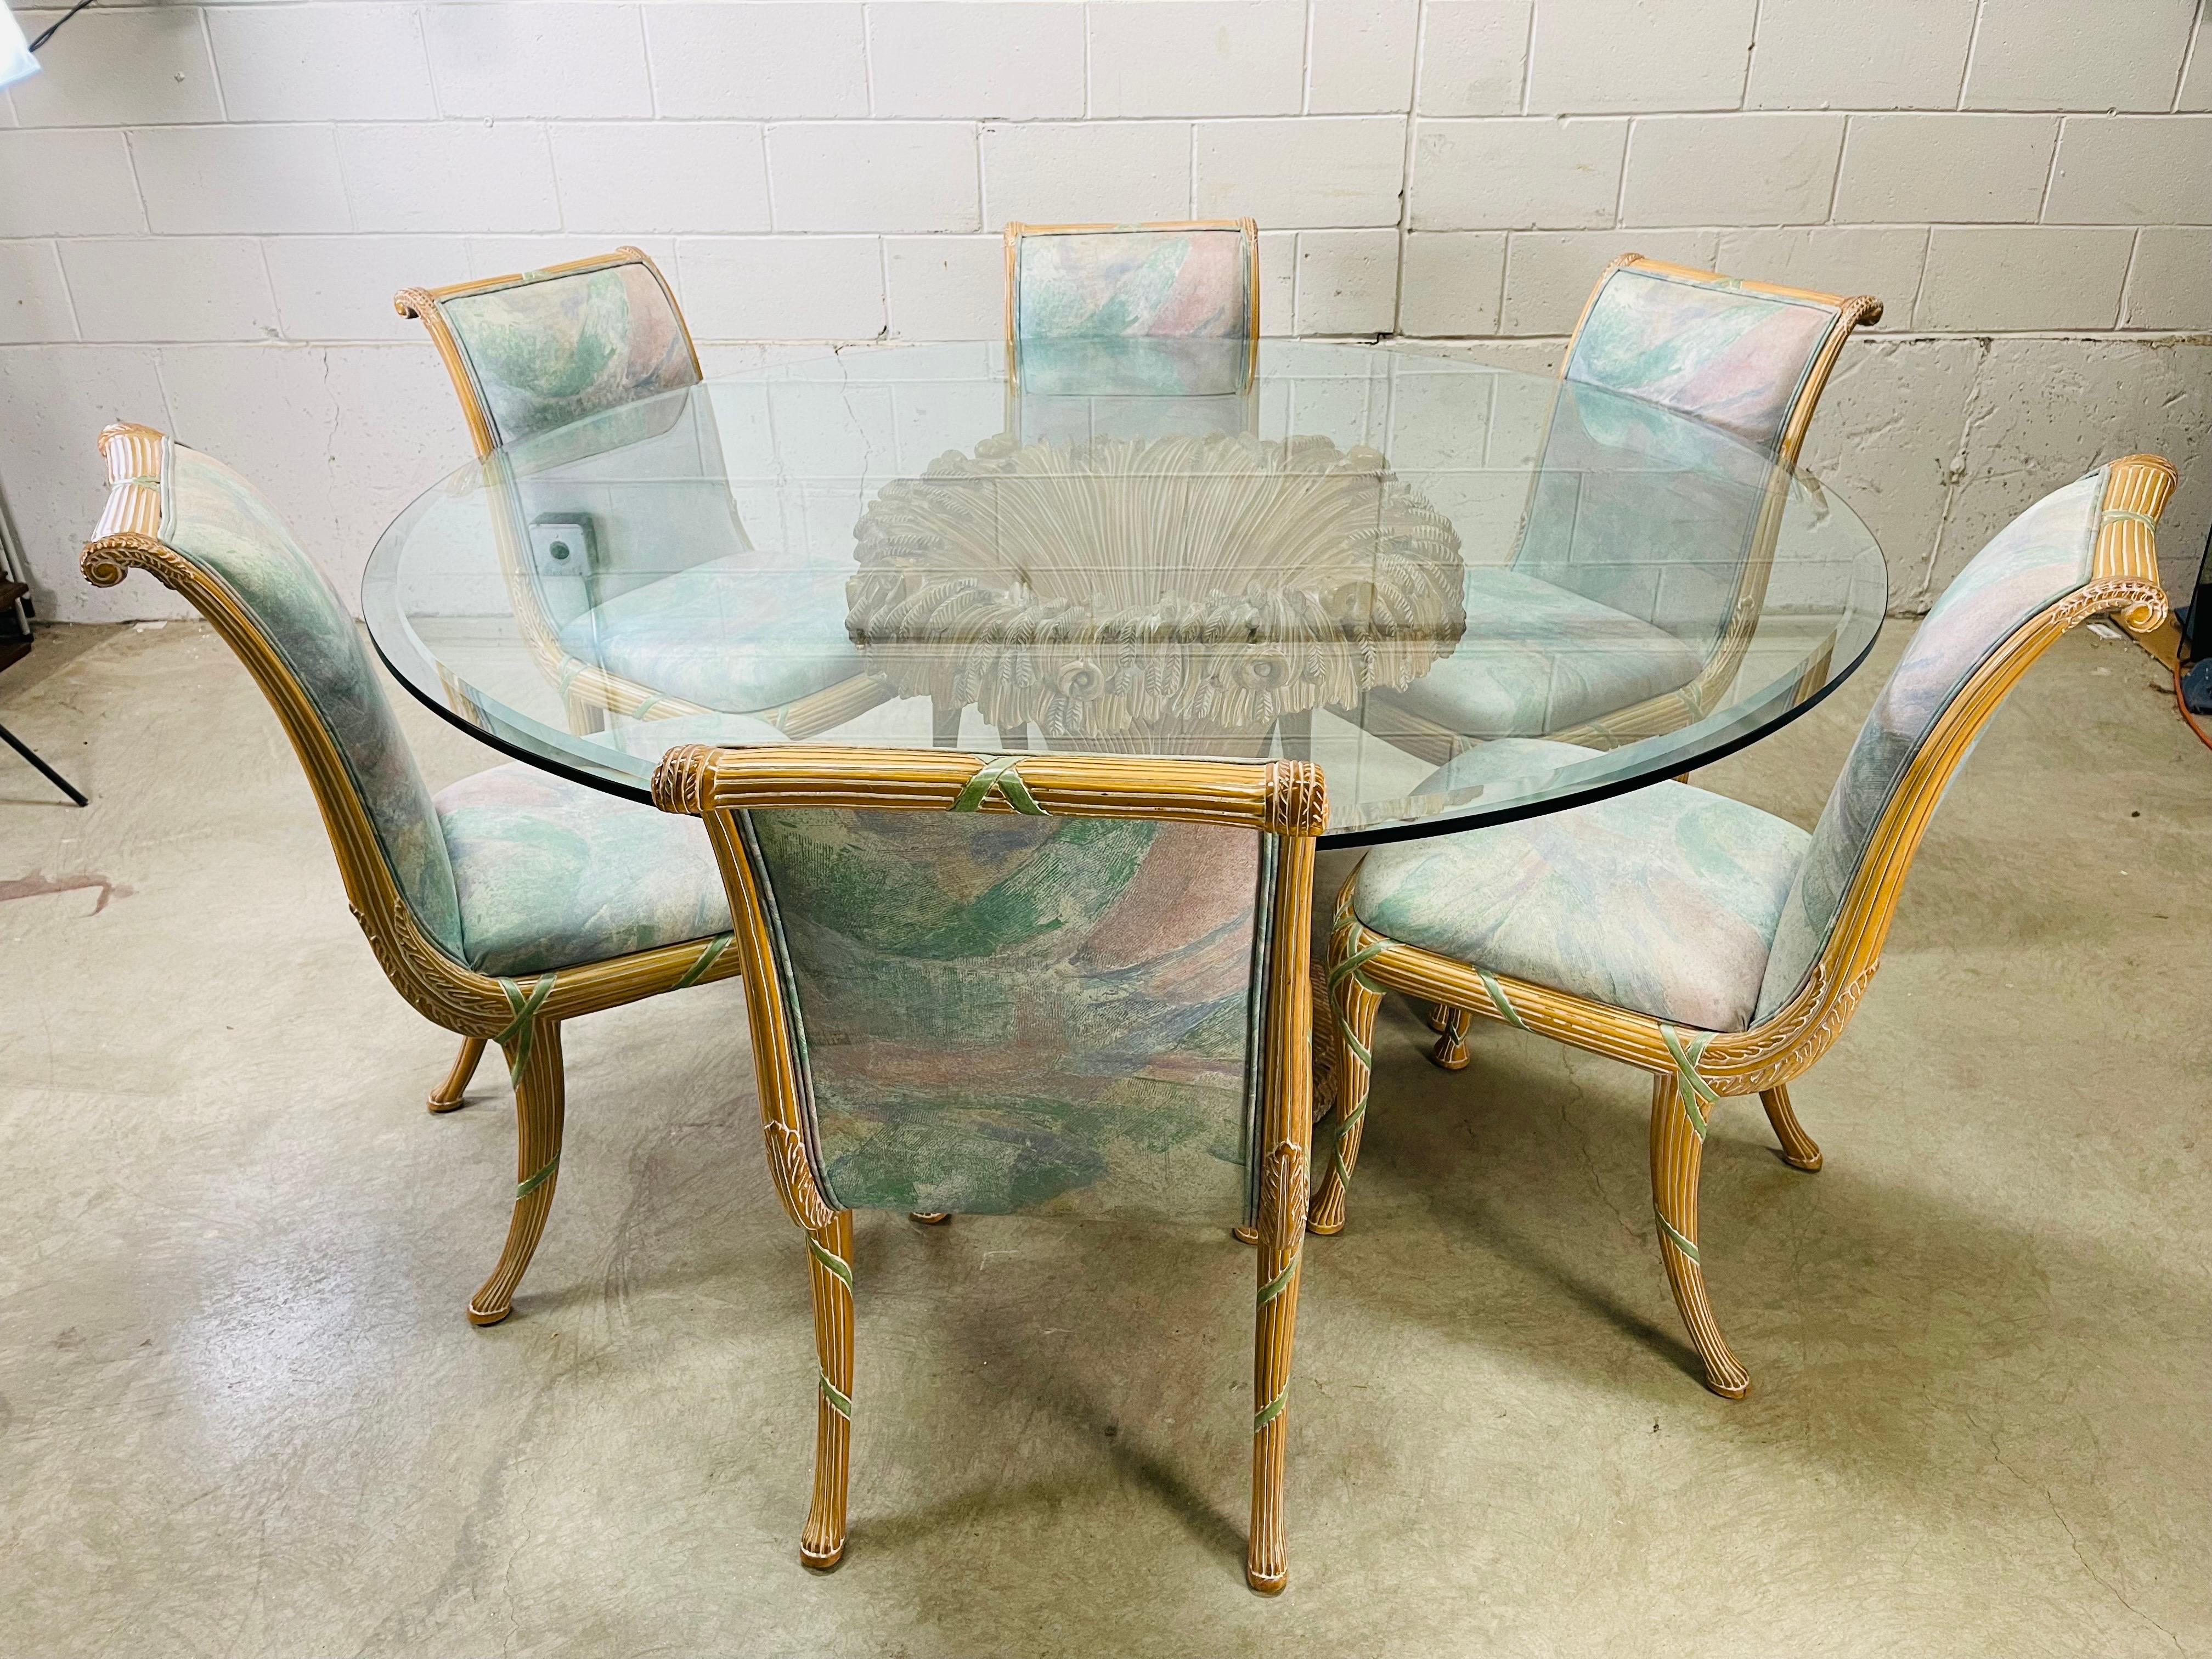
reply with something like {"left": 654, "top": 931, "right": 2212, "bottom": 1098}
{"left": 1310, "top": 456, "right": 2174, "bottom": 1398}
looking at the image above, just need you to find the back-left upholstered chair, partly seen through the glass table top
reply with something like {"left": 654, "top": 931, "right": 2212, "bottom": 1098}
{"left": 392, "top": 248, "right": 891, "bottom": 737}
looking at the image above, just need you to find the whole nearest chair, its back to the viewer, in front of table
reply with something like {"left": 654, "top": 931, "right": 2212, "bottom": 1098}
{"left": 652, "top": 748, "right": 1327, "bottom": 1595}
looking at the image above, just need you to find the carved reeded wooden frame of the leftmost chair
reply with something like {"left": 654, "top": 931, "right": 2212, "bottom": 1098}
{"left": 82, "top": 425, "right": 739, "bottom": 1325}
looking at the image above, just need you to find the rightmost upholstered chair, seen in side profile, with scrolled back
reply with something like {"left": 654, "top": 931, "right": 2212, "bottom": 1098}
{"left": 1312, "top": 456, "right": 2174, "bottom": 1398}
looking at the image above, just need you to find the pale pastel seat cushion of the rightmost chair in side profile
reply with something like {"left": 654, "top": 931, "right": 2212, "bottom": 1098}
{"left": 1352, "top": 739, "right": 1812, "bottom": 1031}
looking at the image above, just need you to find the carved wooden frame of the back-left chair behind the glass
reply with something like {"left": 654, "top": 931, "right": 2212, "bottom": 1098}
{"left": 392, "top": 248, "right": 891, "bottom": 737}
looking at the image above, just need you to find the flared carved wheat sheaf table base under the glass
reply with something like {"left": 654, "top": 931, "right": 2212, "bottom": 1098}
{"left": 847, "top": 431, "right": 1466, "bottom": 752}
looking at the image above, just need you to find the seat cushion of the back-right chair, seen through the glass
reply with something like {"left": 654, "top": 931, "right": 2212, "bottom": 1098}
{"left": 1398, "top": 564, "right": 1703, "bottom": 739}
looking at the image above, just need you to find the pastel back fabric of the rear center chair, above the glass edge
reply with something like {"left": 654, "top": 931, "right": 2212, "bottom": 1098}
{"left": 1011, "top": 228, "right": 1259, "bottom": 343}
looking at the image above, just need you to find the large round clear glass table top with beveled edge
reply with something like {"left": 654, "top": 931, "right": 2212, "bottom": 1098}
{"left": 363, "top": 341, "right": 1887, "bottom": 845}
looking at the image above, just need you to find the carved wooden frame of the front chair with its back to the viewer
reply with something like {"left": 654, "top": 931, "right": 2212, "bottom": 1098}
{"left": 652, "top": 746, "right": 1327, "bottom": 1595}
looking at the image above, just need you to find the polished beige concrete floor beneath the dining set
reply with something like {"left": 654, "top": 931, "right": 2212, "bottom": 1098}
{"left": 0, "top": 624, "right": 2212, "bottom": 1659}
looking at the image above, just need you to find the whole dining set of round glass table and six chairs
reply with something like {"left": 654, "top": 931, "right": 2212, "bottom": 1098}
{"left": 84, "top": 219, "right": 2174, "bottom": 1593}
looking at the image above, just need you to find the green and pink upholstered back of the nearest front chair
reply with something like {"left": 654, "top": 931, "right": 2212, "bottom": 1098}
{"left": 654, "top": 748, "right": 1325, "bottom": 1226}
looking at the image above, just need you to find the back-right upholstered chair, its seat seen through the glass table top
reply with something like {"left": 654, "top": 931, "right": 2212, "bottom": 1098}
{"left": 1369, "top": 255, "right": 1882, "bottom": 763}
